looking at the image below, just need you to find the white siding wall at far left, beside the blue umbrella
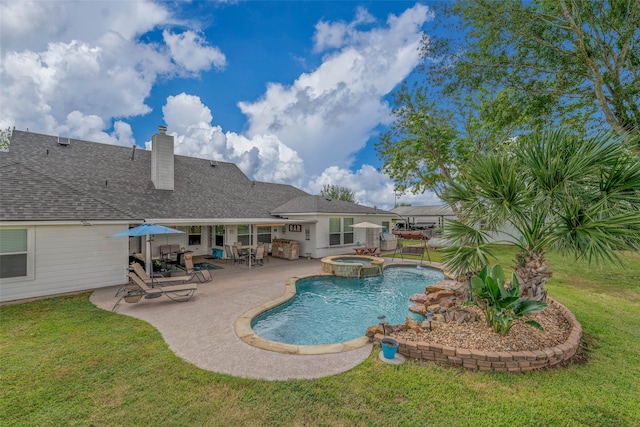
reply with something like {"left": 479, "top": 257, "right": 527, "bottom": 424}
{"left": 0, "top": 225, "right": 129, "bottom": 301}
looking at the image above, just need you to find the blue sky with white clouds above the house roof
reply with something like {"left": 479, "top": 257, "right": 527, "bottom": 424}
{"left": 0, "top": 0, "right": 441, "bottom": 209}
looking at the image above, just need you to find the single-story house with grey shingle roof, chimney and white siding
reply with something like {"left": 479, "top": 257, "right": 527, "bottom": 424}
{"left": 0, "top": 126, "right": 395, "bottom": 302}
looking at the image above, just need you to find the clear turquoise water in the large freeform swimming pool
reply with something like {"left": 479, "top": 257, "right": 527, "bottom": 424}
{"left": 251, "top": 266, "right": 444, "bottom": 345}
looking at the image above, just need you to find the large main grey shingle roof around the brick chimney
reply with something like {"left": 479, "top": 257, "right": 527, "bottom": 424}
{"left": 0, "top": 130, "right": 308, "bottom": 220}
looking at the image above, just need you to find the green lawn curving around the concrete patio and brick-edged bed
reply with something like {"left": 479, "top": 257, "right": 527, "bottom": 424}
{"left": 0, "top": 247, "right": 640, "bottom": 426}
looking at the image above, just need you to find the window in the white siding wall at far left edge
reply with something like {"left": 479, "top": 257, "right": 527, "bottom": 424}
{"left": 0, "top": 228, "right": 29, "bottom": 279}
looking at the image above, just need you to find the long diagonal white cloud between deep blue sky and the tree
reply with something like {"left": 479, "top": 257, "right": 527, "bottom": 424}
{"left": 238, "top": 4, "right": 432, "bottom": 175}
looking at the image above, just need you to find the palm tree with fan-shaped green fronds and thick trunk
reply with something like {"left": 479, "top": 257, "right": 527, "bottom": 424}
{"left": 443, "top": 130, "right": 640, "bottom": 300}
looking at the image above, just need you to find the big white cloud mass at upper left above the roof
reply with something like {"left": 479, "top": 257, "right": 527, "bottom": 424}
{"left": 0, "top": 0, "right": 225, "bottom": 144}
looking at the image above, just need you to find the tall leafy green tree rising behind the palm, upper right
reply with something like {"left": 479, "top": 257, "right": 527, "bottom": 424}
{"left": 376, "top": 0, "right": 640, "bottom": 207}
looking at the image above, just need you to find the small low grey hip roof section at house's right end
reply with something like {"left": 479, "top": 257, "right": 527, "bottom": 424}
{"left": 271, "top": 195, "right": 393, "bottom": 216}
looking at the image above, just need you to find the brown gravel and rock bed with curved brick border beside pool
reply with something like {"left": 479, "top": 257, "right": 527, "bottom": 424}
{"left": 367, "top": 281, "right": 582, "bottom": 372}
